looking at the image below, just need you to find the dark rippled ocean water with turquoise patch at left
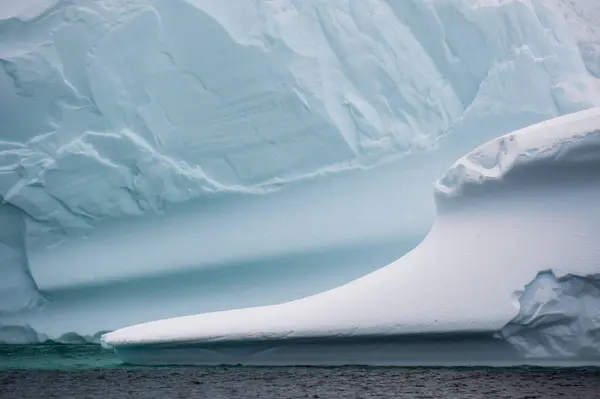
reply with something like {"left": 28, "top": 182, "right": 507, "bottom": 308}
{"left": 0, "top": 345, "right": 600, "bottom": 399}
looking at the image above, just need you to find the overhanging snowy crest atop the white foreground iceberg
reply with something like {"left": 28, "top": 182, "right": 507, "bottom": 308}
{"left": 435, "top": 107, "right": 600, "bottom": 199}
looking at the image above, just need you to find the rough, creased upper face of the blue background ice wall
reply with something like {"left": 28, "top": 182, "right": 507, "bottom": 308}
{"left": 0, "top": 0, "right": 600, "bottom": 232}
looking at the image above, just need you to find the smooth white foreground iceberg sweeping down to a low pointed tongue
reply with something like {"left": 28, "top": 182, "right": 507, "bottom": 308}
{"left": 103, "top": 107, "right": 600, "bottom": 365}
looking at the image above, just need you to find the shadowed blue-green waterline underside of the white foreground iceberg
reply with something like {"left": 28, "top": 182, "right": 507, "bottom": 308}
{"left": 110, "top": 333, "right": 600, "bottom": 367}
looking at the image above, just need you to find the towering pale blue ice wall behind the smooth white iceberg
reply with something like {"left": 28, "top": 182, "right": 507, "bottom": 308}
{"left": 0, "top": 0, "right": 600, "bottom": 342}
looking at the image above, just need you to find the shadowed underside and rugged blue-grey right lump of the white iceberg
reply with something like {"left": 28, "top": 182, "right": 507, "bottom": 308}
{"left": 114, "top": 271, "right": 600, "bottom": 367}
